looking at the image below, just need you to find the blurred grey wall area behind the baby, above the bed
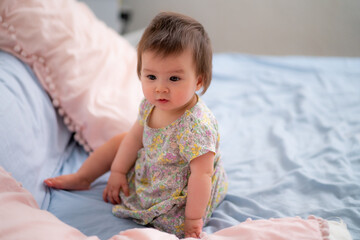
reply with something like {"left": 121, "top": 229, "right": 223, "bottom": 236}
{"left": 81, "top": 0, "right": 360, "bottom": 57}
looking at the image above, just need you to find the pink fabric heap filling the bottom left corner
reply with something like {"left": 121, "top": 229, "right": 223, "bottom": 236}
{"left": 0, "top": 167, "right": 98, "bottom": 240}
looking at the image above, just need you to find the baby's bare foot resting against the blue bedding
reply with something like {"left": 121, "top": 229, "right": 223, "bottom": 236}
{"left": 44, "top": 173, "right": 90, "bottom": 190}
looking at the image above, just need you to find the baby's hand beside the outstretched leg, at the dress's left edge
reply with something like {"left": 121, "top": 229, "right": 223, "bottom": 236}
{"left": 103, "top": 172, "right": 129, "bottom": 204}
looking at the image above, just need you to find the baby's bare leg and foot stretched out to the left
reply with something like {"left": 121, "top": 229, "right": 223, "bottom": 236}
{"left": 44, "top": 133, "right": 126, "bottom": 190}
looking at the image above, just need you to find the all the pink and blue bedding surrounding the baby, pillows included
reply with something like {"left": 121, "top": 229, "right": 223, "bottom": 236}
{"left": 0, "top": 0, "right": 360, "bottom": 240}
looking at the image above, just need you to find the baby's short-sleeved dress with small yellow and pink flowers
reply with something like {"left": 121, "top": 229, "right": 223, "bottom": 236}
{"left": 112, "top": 98, "right": 227, "bottom": 237}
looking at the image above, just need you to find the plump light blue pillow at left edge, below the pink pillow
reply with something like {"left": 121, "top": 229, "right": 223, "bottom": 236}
{"left": 0, "top": 51, "right": 71, "bottom": 209}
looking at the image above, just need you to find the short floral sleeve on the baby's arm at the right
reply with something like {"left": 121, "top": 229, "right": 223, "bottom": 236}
{"left": 179, "top": 117, "right": 219, "bottom": 162}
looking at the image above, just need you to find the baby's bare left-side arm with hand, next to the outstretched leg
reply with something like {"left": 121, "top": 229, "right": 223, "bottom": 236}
{"left": 103, "top": 121, "right": 143, "bottom": 204}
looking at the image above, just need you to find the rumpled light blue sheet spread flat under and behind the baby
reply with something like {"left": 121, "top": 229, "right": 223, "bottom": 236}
{"left": 48, "top": 54, "right": 360, "bottom": 239}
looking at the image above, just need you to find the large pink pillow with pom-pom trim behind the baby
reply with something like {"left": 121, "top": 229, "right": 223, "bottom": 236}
{"left": 0, "top": 0, "right": 142, "bottom": 151}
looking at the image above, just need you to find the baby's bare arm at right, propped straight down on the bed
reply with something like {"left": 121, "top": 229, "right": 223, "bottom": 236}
{"left": 185, "top": 152, "right": 215, "bottom": 238}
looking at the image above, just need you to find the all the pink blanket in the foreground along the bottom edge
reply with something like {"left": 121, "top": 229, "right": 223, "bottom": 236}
{"left": 0, "top": 167, "right": 329, "bottom": 240}
